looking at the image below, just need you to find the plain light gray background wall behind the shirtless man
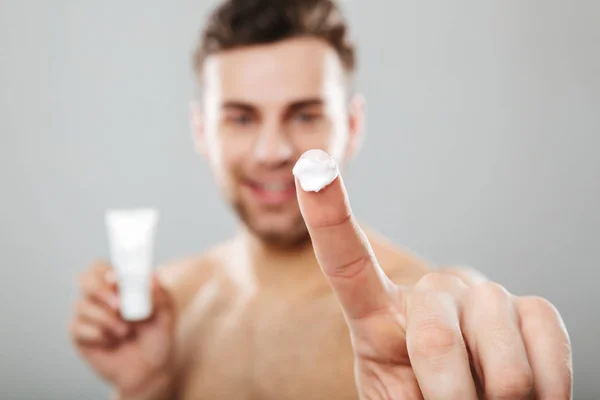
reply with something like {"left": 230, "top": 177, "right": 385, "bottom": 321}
{"left": 0, "top": 0, "right": 600, "bottom": 400}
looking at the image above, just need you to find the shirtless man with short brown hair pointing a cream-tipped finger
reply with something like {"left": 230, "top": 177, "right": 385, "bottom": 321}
{"left": 71, "top": 0, "right": 572, "bottom": 400}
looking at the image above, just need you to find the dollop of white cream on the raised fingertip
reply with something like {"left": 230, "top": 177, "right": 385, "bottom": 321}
{"left": 292, "top": 149, "right": 338, "bottom": 192}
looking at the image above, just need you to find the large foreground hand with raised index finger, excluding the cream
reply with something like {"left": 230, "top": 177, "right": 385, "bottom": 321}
{"left": 297, "top": 151, "right": 572, "bottom": 400}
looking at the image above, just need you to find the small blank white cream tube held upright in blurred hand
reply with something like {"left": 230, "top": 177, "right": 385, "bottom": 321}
{"left": 105, "top": 208, "right": 158, "bottom": 321}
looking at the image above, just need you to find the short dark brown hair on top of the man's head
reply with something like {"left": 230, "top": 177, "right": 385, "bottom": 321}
{"left": 194, "top": 0, "right": 356, "bottom": 74}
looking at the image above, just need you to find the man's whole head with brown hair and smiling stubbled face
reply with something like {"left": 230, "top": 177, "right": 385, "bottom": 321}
{"left": 193, "top": 0, "right": 363, "bottom": 246}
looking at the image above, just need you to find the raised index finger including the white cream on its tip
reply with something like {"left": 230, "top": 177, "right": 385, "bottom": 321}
{"left": 294, "top": 150, "right": 391, "bottom": 319}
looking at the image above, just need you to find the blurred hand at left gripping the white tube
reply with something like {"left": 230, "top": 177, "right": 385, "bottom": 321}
{"left": 70, "top": 263, "right": 175, "bottom": 397}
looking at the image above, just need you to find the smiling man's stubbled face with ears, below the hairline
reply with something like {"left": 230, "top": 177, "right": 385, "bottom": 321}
{"left": 194, "top": 38, "right": 361, "bottom": 246}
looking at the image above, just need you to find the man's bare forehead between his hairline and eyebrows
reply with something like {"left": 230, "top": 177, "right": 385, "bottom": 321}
{"left": 203, "top": 39, "right": 345, "bottom": 104}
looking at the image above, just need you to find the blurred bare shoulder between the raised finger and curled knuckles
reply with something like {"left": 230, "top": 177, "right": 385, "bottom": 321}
{"left": 365, "top": 229, "right": 433, "bottom": 285}
